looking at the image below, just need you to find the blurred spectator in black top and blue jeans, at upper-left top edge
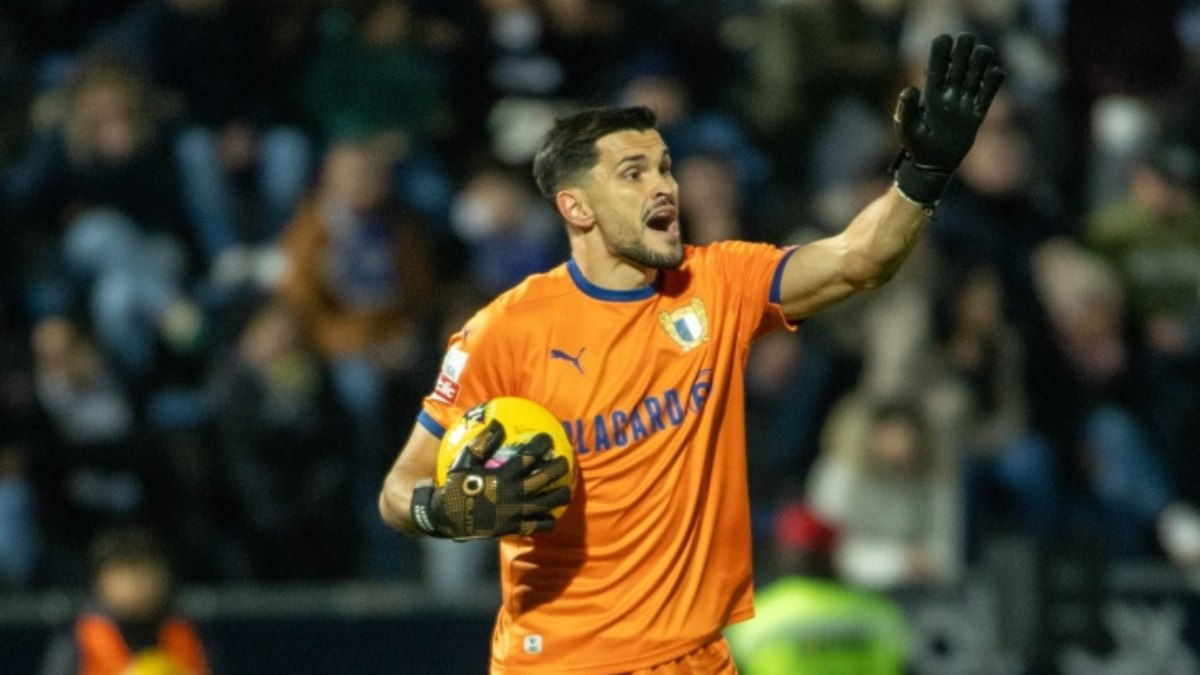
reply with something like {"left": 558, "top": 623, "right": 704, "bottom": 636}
{"left": 146, "top": 0, "right": 314, "bottom": 276}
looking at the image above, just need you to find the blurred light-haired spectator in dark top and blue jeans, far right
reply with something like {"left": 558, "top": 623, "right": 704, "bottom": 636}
{"left": 1026, "top": 239, "right": 1195, "bottom": 560}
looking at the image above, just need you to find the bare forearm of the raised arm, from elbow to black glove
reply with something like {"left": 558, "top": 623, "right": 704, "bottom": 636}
{"left": 841, "top": 186, "right": 929, "bottom": 288}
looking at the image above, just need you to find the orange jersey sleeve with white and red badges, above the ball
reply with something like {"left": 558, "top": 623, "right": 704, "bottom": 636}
{"left": 418, "top": 300, "right": 512, "bottom": 438}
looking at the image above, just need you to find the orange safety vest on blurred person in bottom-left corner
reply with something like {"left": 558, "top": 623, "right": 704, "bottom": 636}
{"left": 74, "top": 614, "right": 209, "bottom": 675}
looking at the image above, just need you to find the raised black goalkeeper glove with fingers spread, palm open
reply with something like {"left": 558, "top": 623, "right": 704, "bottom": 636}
{"left": 893, "top": 32, "right": 1004, "bottom": 210}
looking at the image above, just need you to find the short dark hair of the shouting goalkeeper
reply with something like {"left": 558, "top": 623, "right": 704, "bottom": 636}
{"left": 533, "top": 106, "right": 658, "bottom": 202}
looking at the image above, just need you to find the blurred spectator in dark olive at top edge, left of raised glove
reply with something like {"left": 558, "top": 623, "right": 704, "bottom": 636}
{"left": 733, "top": 1, "right": 902, "bottom": 192}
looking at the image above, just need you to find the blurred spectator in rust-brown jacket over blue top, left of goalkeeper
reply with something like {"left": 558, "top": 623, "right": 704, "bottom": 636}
{"left": 278, "top": 141, "right": 437, "bottom": 574}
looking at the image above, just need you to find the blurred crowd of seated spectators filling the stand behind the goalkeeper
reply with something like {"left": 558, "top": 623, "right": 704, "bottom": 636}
{"left": 0, "top": 0, "right": 1200, "bottom": 600}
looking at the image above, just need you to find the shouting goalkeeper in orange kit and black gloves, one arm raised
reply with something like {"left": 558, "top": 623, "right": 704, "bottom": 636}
{"left": 379, "top": 35, "right": 1003, "bottom": 674}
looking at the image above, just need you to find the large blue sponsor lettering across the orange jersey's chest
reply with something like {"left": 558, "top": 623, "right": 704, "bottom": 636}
{"left": 563, "top": 369, "right": 713, "bottom": 455}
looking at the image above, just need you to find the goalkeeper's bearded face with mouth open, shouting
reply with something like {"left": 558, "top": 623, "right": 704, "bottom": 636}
{"left": 584, "top": 130, "right": 683, "bottom": 269}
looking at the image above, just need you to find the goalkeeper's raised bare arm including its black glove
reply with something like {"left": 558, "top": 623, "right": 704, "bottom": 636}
{"left": 780, "top": 34, "right": 1004, "bottom": 321}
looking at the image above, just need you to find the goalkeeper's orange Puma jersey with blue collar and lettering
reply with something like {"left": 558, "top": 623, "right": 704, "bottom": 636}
{"left": 419, "top": 241, "right": 790, "bottom": 674}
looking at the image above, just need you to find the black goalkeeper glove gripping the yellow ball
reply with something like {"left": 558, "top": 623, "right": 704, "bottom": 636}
{"left": 410, "top": 420, "right": 571, "bottom": 540}
